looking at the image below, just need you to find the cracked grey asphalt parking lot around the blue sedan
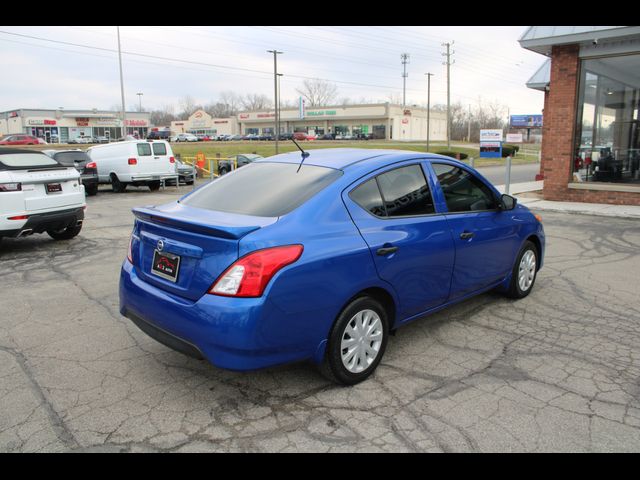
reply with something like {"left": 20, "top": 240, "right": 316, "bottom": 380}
{"left": 0, "top": 187, "right": 640, "bottom": 452}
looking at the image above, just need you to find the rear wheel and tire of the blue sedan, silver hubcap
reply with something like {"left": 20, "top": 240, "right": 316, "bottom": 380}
{"left": 319, "top": 296, "right": 389, "bottom": 385}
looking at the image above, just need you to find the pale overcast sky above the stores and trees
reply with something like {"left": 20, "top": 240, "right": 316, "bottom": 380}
{"left": 0, "top": 26, "right": 545, "bottom": 115}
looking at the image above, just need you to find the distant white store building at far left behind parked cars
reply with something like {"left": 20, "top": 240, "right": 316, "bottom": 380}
{"left": 0, "top": 108, "right": 151, "bottom": 143}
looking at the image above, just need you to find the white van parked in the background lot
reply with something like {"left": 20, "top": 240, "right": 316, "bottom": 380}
{"left": 87, "top": 140, "right": 178, "bottom": 192}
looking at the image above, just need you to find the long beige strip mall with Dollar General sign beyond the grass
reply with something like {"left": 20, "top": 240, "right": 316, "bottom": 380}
{"left": 171, "top": 103, "right": 447, "bottom": 141}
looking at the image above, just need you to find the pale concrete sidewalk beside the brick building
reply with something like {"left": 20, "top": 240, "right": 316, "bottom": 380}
{"left": 496, "top": 180, "right": 640, "bottom": 218}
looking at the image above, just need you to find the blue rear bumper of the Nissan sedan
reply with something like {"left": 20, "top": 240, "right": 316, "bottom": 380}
{"left": 120, "top": 260, "right": 311, "bottom": 371}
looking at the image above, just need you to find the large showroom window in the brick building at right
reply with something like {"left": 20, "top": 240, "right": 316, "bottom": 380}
{"left": 572, "top": 55, "right": 640, "bottom": 184}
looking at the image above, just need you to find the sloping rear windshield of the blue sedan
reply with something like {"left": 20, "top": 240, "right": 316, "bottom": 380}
{"left": 182, "top": 163, "right": 342, "bottom": 217}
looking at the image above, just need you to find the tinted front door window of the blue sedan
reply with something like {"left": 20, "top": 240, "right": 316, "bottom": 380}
{"left": 432, "top": 163, "right": 498, "bottom": 212}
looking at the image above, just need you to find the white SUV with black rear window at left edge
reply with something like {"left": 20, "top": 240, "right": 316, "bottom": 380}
{"left": 0, "top": 148, "right": 86, "bottom": 246}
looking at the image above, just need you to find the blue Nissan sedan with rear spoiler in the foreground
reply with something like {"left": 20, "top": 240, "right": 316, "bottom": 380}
{"left": 120, "top": 149, "right": 545, "bottom": 385}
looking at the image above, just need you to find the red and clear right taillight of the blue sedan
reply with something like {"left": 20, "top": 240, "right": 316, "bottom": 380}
{"left": 209, "top": 245, "right": 303, "bottom": 297}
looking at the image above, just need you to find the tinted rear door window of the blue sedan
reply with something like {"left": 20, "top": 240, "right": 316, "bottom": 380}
{"left": 350, "top": 165, "right": 435, "bottom": 217}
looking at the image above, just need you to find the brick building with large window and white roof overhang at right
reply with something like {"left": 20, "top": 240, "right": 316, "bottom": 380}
{"left": 520, "top": 26, "right": 640, "bottom": 205}
